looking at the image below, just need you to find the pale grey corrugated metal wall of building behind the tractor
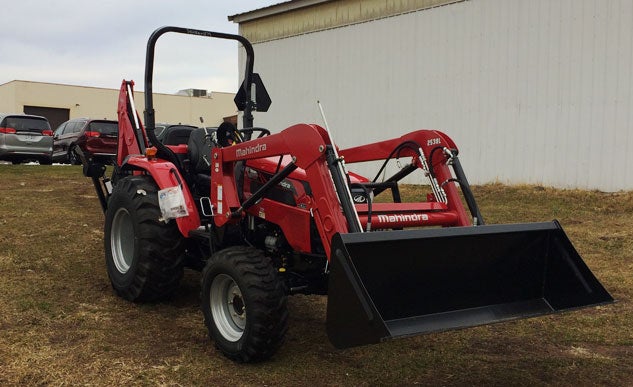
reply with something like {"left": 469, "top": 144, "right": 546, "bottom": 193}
{"left": 244, "top": 0, "right": 633, "bottom": 191}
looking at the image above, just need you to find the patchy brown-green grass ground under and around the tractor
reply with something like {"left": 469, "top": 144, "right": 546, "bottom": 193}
{"left": 0, "top": 165, "right": 633, "bottom": 386}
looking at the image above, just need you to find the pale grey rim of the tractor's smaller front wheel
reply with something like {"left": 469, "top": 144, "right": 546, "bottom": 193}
{"left": 209, "top": 274, "right": 246, "bottom": 342}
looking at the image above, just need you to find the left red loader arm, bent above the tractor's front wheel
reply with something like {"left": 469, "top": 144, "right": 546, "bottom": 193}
{"left": 211, "top": 124, "right": 355, "bottom": 257}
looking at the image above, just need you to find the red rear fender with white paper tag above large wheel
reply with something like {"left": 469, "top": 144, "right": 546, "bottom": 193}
{"left": 124, "top": 156, "right": 200, "bottom": 237}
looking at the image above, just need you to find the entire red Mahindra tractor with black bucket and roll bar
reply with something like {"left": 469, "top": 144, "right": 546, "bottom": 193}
{"left": 84, "top": 27, "right": 613, "bottom": 362}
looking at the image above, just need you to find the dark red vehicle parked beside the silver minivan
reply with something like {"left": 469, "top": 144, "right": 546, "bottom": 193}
{"left": 53, "top": 118, "right": 119, "bottom": 165}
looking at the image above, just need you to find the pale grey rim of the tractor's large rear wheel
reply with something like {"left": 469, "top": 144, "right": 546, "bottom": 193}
{"left": 110, "top": 208, "right": 134, "bottom": 274}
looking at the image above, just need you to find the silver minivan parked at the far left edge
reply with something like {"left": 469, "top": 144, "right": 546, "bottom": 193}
{"left": 0, "top": 113, "right": 53, "bottom": 165}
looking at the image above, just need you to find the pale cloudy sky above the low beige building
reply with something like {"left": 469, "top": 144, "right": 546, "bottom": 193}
{"left": 0, "top": 0, "right": 283, "bottom": 94}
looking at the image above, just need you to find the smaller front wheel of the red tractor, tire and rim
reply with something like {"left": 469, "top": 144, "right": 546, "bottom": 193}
{"left": 201, "top": 246, "right": 288, "bottom": 363}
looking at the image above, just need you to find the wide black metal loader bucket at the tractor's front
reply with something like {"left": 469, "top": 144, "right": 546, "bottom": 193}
{"left": 327, "top": 221, "right": 613, "bottom": 348}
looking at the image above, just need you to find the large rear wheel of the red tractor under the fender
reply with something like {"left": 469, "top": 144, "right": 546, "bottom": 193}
{"left": 104, "top": 176, "right": 184, "bottom": 302}
